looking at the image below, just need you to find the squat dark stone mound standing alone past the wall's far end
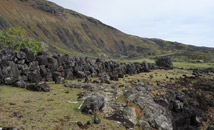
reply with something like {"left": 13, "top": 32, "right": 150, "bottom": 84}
{"left": 156, "top": 57, "right": 173, "bottom": 69}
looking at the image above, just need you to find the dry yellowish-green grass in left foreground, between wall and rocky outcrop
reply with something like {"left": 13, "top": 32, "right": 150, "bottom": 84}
{"left": 0, "top": 82, "right": 123, "bottom": 130}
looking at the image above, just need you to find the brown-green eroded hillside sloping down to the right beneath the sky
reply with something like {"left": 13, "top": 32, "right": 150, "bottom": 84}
{"left": 0, "top": 0, "right": 214, "bottom": 61}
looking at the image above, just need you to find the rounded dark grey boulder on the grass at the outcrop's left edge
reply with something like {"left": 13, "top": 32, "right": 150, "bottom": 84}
{"left": 80, "top": 96, "right": 105, "bottom": 113}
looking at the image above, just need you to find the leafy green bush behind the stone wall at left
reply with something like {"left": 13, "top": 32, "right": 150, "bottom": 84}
{"left": 0, "top": 27, "right": 42, "bottom": 54}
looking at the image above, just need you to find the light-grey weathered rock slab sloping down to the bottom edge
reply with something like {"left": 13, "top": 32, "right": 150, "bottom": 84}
{"left": 124, "top": 87, "right": 173, "bottom": 130}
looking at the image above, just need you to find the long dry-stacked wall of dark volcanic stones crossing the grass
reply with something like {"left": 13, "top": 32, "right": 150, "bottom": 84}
{"left": 0, "top": 49, "right": 156, "bottom": 91}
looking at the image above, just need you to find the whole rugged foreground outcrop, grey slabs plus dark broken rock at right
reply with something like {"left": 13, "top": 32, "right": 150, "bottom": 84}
{"left": 65, "top": 76, "right": 213, "bottom": 130}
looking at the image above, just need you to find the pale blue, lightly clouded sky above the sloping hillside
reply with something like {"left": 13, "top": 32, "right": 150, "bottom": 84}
{"left": 49, "top": 0, "right": 214, "bottom": 47}
